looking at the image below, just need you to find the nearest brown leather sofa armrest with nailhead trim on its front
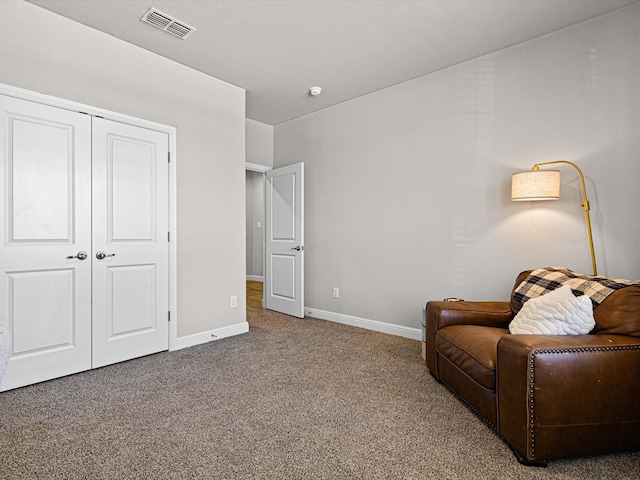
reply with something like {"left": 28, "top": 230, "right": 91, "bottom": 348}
{"left": 496, "top": 335, "right": 640, "bottom": 460}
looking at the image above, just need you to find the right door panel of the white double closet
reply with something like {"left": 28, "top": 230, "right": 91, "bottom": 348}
{"left": 91, "top": 118, "right": 169, "bottom": 368}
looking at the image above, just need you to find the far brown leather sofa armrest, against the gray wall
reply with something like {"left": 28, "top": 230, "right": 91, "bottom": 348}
{"left": 425, "top": 301, "right": 513, "bottom": 377}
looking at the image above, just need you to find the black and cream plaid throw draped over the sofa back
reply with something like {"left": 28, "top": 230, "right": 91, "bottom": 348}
{"left": 511, "top": 267, "right": 640, "bottom": 308}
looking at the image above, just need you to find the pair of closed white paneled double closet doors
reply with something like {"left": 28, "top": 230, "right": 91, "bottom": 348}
{"left": 0, "top": 95, "right": 169, "bottom": 390}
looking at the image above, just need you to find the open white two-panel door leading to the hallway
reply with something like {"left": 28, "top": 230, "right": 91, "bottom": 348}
{"left": 264, "top": 163, "right": 304, "bottom": 318}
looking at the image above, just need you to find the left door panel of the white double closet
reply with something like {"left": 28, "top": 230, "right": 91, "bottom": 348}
{"left": 0, "top": 95, "right": 91, "bottom": 390}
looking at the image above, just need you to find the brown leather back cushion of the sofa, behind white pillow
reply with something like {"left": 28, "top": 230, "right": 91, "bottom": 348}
{"left": 510, "top": 270, "right": 640, "bottom": 338}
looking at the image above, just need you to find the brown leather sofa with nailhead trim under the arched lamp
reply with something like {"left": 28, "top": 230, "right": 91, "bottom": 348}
{"left": 425, "top": 271, "right": 640, "bottom": 466}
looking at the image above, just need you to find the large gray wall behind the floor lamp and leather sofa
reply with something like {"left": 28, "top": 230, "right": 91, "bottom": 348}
{"left": 274, "top": 4, "right": 640, "bottom": 328}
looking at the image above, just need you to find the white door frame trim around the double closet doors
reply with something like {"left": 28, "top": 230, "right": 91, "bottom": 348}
{"left": 0, "top": 83, "right": 180, "bottom": 351}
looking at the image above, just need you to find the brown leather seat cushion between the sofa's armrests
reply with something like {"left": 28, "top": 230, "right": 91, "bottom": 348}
{"left": 435, "top": 325, "right": 509, "bottom": 391}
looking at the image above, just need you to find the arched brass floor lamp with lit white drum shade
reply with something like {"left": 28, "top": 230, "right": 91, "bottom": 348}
{"left": 511, "top": 160, "right": 598, "bottom": 275}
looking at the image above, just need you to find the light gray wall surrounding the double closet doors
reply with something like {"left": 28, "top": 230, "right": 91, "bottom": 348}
{"left": 0, "top": 1, "right": 246, "bottom": 337}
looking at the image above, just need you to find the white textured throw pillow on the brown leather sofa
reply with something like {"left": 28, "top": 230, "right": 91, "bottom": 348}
{"left": 509, "top": 285, "right": 596, "bottom": 335}
